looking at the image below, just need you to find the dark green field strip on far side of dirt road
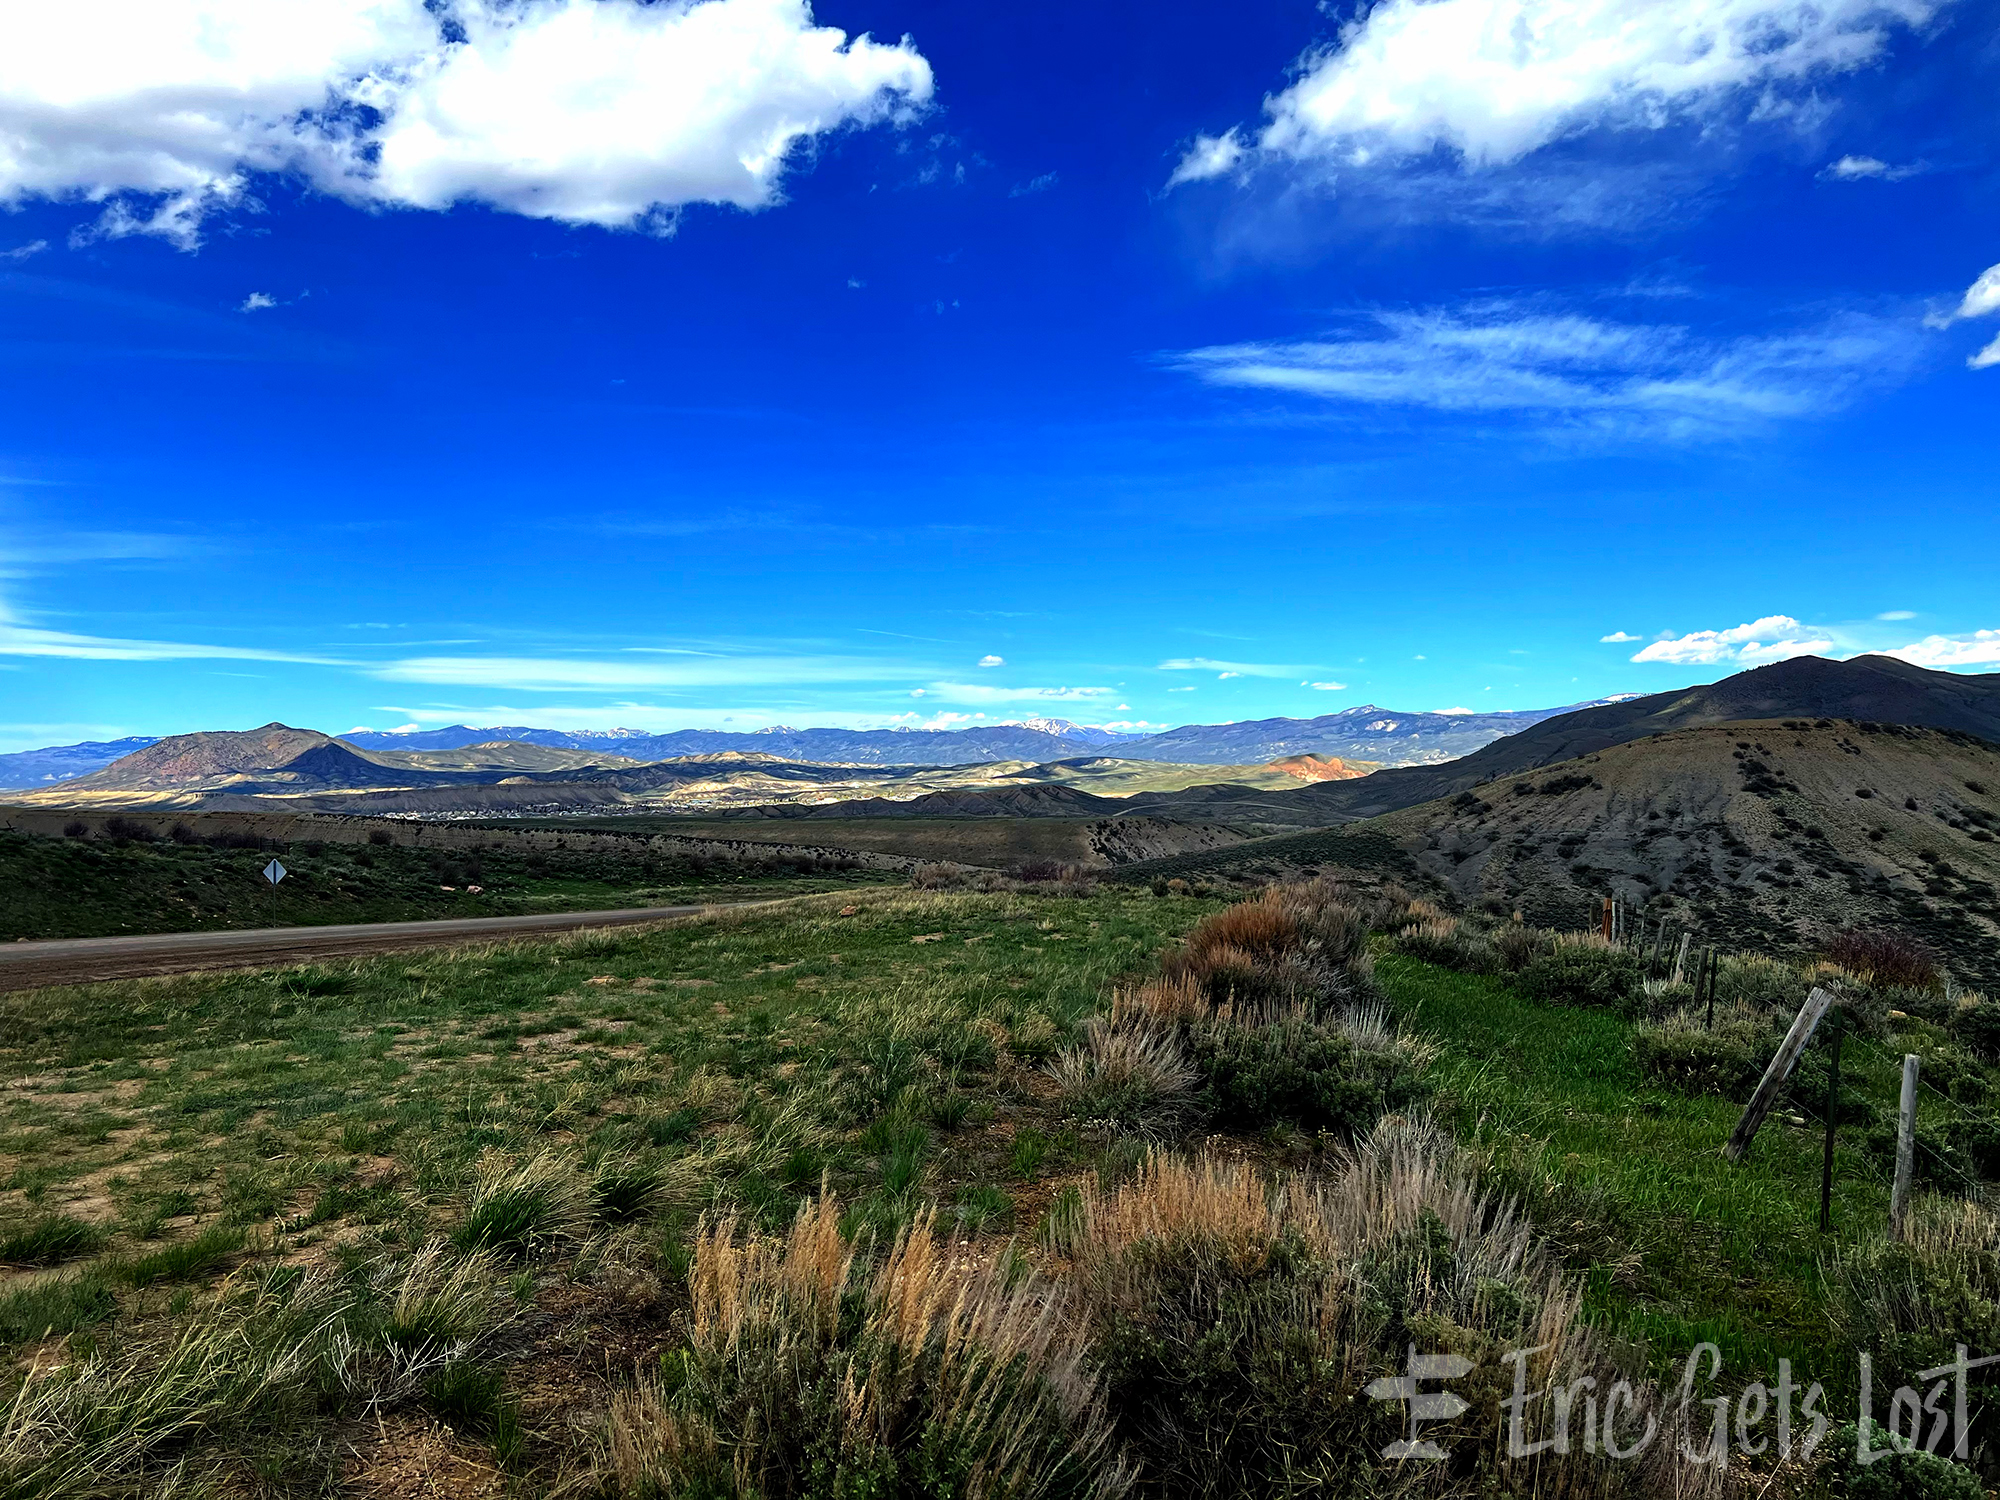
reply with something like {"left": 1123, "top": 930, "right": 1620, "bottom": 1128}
{"left": 0, "top": 832, "right": 884, "bottom": 942}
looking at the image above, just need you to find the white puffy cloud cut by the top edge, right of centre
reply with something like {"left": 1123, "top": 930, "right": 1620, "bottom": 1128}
{"left": 1174, "top": 0, "right": 1936, "bottom": 182}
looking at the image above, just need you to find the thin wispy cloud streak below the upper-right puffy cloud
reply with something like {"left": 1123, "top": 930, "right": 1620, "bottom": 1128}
{"left": 1170, "top": 300, "right": 1920, "bottom": 438}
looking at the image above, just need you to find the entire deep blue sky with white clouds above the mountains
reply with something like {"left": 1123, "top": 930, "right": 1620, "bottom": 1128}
{"left": 0, "top": 0, "right": 2000, "bottom": 748}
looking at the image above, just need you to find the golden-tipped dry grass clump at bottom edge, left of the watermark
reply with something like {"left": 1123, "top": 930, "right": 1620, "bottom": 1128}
{"left": 610, "top": 1194, "right": 1132, "bottom": 1500}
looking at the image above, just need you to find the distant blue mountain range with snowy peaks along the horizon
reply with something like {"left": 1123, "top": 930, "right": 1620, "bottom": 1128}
{"left": 0, "top": 700, "right": 1610, "bottom": 790}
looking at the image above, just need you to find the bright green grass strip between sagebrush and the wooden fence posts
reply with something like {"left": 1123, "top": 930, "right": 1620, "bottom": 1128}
{"left": 1376, "top": 956, "right": 1888, "bottom": 1384}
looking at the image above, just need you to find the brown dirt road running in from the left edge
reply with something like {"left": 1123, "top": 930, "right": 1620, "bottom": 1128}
{"left": 0, "top": 906, "right": 720, "bottom": 990}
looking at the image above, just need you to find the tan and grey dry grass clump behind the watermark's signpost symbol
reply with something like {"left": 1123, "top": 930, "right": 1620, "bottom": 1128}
{"left": 1064, "top": 1118, "right": 1712, "bottom": 1500}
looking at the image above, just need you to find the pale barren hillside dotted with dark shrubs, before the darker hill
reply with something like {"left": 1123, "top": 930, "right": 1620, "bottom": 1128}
{"left": 1366, "top": 720, "right": 2000, "bottom": 986}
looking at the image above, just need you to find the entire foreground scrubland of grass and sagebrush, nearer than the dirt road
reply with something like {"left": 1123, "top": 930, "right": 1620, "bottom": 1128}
{"left": 0, "top": 878, "right": 2000, "bottom": 1500}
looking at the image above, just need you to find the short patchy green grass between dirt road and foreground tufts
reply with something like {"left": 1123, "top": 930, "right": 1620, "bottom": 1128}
{"left": 0, "top": 890, "right": 1212, "bottom": 1320}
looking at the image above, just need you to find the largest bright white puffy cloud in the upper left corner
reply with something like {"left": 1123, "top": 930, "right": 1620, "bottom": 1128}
{"left": 0, "top": 0, "right": 932, "bottom": 244}
